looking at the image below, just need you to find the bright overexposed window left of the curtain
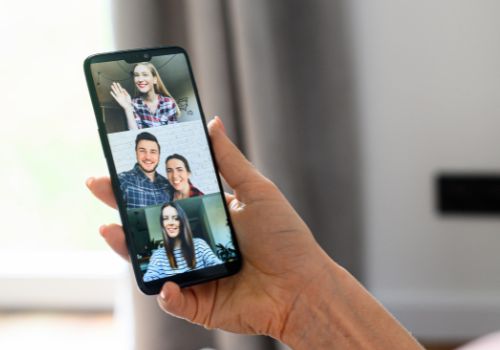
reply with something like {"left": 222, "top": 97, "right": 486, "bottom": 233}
{"left": 0, "top": 0, "right": 123, "bottom": 307}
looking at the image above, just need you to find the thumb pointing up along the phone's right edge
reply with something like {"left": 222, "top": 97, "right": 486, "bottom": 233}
{"left": 208, "top": 117, "right": 264, "bottom": 192}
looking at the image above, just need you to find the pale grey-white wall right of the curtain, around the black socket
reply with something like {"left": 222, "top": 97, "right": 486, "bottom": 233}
{"left": 346, "top": 0, "right": 500, "bottom": 339}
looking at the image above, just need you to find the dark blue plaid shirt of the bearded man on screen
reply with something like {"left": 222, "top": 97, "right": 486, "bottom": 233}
{"left": 118, "top": 163, "right": 172, "bottom": 209}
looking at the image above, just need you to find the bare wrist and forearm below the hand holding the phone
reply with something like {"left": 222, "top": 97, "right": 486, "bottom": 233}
{"left": 280, "top": 259, "right": 423, "bottom": 350}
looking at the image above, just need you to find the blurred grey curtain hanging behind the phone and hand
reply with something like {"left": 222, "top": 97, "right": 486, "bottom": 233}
{"left": 112, "top": 0, "right": 362, "bottom": 350}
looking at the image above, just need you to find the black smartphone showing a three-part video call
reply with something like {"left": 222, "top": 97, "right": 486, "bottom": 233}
{"left": 84, "top": 47, "right": 242, "bottom": 295}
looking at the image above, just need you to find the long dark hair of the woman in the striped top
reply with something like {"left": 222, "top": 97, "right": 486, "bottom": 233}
{"left": 160, "top": 202, "right": 196, "bottom": 269}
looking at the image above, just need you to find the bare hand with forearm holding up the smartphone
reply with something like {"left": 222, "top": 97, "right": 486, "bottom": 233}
{"left": 87, "top": 117, "right": 423, "bottom": 350}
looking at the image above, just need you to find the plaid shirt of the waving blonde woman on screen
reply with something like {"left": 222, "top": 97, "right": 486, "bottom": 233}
{"left": 132, "top": 95, "right": 177, "bottom": 129}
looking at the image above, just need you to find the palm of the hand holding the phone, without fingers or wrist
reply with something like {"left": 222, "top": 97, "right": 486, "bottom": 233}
{"left": 172, "top": 183, "right": 322, "bottom": 337}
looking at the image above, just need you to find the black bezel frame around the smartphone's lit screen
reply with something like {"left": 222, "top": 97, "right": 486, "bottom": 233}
{"left": 84, "top": 46, "right": 242, "bottom": 295}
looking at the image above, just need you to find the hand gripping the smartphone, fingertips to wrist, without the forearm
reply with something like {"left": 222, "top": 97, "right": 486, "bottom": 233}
{"left": 87, "top": 117, "right": 331, "bottom": 339}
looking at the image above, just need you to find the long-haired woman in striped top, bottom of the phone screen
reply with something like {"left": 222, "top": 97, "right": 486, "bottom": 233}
{"left": 143, "top": 202, "right": 222, "bottom": 282}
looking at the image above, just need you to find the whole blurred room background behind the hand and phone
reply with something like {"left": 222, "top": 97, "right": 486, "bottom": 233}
{"left": 0, "top": 0, "right": 500, "bottom": 349}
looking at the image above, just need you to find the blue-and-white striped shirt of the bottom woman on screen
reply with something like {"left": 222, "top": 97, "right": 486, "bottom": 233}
{"left": 143, "top": 238, "right": 222, "bottom": 282}
